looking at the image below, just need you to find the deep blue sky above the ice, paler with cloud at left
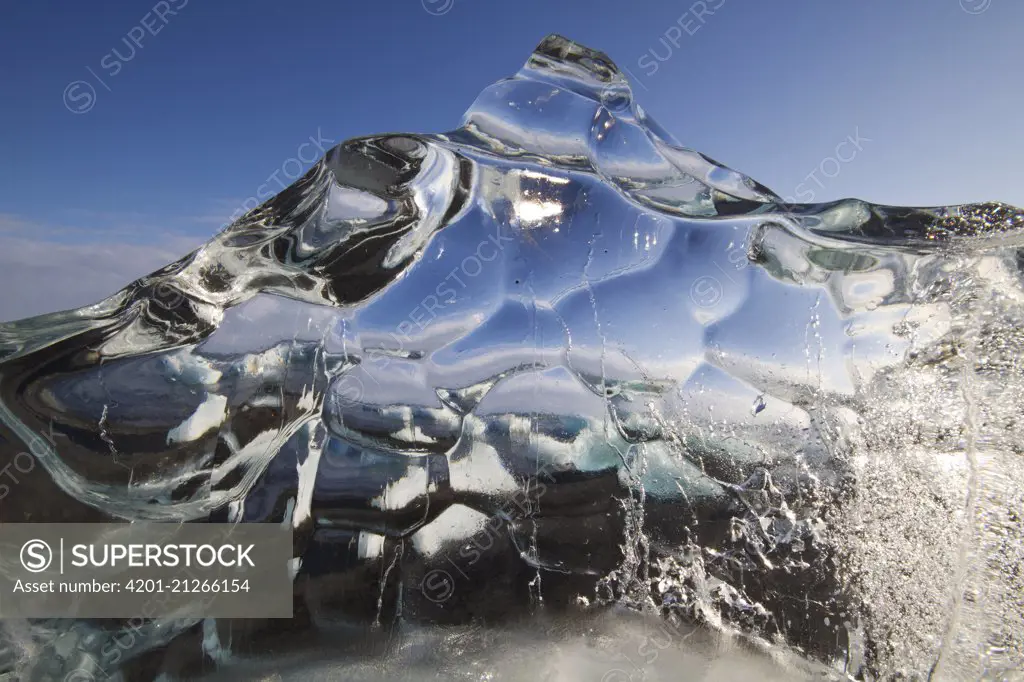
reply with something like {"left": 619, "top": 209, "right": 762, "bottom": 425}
{"left": 0, "top": 0, "right": 1024, "bottom": 319}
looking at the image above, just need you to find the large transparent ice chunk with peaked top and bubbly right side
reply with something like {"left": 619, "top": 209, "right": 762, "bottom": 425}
{"left": 0, "top": 36, "right": 1024, "bottom": 680}
